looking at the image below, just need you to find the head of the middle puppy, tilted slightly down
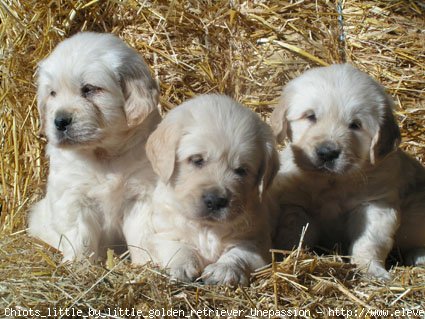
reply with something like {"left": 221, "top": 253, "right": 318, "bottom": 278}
{"left": 146, "top": 95, "right": 279, "bottom": 222}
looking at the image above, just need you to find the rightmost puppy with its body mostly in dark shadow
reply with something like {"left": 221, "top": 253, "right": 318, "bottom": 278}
{"left": 271, "top": 64, "right": 425, "bottom": 279}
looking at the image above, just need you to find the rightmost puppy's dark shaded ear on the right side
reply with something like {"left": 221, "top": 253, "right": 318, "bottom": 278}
{"left": 370, "top": 93, "right": 401, "bottom": 164}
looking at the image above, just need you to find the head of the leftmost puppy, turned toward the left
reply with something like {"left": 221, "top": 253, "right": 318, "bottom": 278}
{"left": 37, "top": 32, "right": 159, "bottom": 148}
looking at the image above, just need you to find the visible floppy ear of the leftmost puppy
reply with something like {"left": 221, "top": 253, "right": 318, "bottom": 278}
{"left": 118, "top": 57, "right": 159, "bottom": 127}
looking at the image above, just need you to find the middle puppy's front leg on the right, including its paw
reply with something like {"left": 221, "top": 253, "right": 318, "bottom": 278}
{"left": 201, "top": 242, "right": 267, "bottom": 286}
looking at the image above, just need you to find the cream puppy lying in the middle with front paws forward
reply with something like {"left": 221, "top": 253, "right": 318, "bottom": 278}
{"left": 125, "top": 95, "right": 279, "bottom": 285}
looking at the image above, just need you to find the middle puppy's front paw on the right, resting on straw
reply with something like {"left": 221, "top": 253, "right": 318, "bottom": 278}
{"left": 201, "top": 262, "right": 249, "bottom": 286}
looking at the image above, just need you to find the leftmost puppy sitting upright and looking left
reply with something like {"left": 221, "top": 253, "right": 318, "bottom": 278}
{"left": 29, "top": 32, "right": 160, "bottom": 260}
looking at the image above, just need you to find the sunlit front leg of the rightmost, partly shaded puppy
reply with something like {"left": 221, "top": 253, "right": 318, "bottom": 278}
{"left": 348, "top": 203, "right": 399, "bottom": 280}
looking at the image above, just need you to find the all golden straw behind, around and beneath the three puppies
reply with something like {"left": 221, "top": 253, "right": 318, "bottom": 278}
{"left": 0, "top": 0, "right": 425, "bottom": 318}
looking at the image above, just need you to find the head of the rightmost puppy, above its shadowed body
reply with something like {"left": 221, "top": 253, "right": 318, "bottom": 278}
{"left": 271, "top": 64, "right": 400, "bottom": 174}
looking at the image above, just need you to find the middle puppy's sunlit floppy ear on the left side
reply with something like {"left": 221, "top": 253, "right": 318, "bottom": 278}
{"left": 146, "top": 119, "right": 181, "bottom": 183}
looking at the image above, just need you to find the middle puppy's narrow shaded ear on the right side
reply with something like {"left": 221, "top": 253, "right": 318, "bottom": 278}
{"left": 258, "top": 141, "right": 280, "bottom": 197}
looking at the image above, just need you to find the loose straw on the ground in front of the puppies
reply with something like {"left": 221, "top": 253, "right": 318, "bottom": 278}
{"left": 0, "top": 234, "right": 425, "bottom": 318}
